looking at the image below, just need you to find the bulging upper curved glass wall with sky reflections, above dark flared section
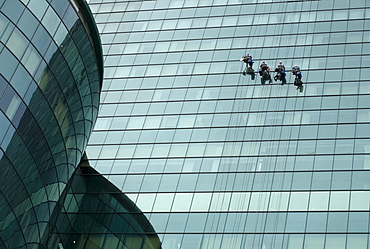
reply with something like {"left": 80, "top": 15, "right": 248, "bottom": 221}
{"left": 0, "top": 0, "right": 102, "bottom": 249}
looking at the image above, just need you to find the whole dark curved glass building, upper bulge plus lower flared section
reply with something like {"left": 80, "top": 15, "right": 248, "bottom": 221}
{"left": 0, "top": 0, "right": 161, "bottom": 249}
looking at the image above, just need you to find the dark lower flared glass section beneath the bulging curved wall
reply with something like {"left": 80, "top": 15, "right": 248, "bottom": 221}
{"left": 48, "top": 160, "right": 161, "bottom": 249}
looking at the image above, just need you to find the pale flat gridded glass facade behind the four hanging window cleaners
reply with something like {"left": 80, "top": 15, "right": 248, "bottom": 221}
{"left": 87, "top": 0, "right": 370, "bottom": 249}
